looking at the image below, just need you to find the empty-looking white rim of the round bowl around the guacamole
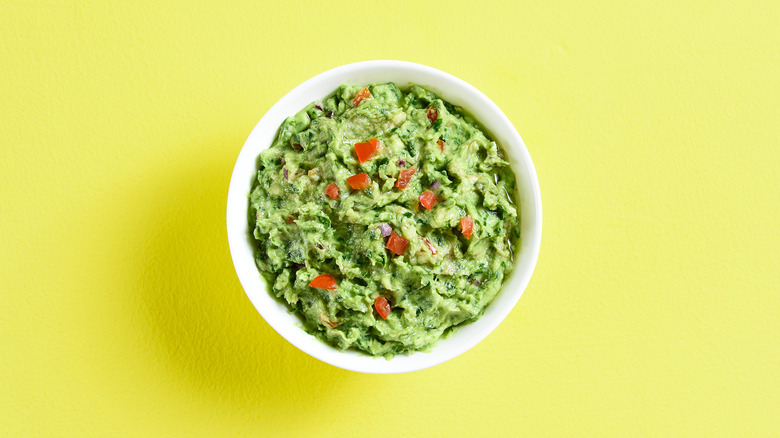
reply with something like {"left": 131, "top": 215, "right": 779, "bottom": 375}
{"left": 227, "top": 61, "right": 542, "bottom": 374}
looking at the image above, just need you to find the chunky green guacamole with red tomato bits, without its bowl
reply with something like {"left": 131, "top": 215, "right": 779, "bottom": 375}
{"left": 249, "top": 83, "right": 520, "bottom": 358}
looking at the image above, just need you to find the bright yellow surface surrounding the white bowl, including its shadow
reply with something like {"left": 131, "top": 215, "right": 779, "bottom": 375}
{"left": 0, "top": 0, "right": 780, "bottom": 436}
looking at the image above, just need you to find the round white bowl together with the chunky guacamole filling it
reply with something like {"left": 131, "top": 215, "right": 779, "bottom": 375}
{"left": 227, "top": 61, "right": 541, "bottom": 373}
